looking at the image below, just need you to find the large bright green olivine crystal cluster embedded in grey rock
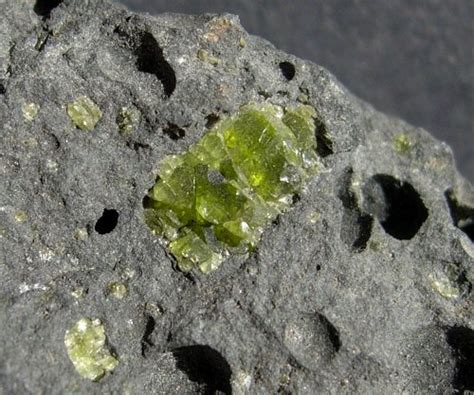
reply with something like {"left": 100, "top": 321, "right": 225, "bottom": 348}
{"left": 145, "top": 104, "right": 317, "bottom": 273}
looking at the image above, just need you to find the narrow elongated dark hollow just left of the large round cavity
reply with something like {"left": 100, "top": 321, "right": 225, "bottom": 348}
{"left": 338, "top": 168, "right": 373, "bottom": 252}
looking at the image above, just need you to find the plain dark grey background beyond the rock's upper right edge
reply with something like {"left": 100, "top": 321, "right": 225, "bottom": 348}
{"left": 120, "top": 0, "right": 474, "bottom": 181}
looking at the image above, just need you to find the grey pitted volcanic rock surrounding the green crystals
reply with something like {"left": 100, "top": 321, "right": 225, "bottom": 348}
{"left": 0, "top": 0, "right": 474, "bottom": 394}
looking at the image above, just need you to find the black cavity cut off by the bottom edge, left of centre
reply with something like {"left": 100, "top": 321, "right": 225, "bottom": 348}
{"left": 173, "top": 345, "right": 232, "bottom": 395}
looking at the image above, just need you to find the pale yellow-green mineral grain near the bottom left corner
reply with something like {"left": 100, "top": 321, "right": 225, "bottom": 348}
{"left": 64, "top": 318, "right": 118, "bottom": 381}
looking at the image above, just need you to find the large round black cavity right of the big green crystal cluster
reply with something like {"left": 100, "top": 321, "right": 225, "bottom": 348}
{"left": 364, "top": 174, "right": 428, "bottom": 240}
